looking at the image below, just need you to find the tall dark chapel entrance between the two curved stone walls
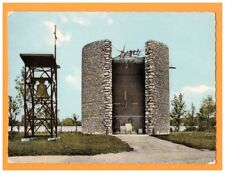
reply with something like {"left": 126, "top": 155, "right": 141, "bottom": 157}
{"left": 112, "top": 56, "right": 145, "bottom": 134}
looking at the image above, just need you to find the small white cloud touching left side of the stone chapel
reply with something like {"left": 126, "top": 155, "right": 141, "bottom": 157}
{"left": 66, "top": 69, "right": 81, "bottom": 90}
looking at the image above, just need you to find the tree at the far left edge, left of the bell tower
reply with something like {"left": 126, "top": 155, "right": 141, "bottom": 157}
{"left": 8, "top": 96, "right": 20, "bottom": 132}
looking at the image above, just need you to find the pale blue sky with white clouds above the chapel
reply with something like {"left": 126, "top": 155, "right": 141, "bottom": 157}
{"left": 8, "top": 12, "right": 215, "bottom": 119}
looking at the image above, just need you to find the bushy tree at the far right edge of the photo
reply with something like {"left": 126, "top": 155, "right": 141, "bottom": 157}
{"left": 198, "top": 96, "right": 216, "bottom": 131}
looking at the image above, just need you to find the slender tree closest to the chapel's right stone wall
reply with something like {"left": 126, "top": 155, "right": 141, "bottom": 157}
{"left": 170, "top": 93, "right": 186, "bottom": 131}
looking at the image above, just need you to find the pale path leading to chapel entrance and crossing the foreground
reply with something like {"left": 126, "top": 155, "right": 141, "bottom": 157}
{"left": 9, "top": 135, "right": 215, "bottom": 164}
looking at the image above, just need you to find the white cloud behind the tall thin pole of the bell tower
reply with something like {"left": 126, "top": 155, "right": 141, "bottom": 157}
{"left": 44, "top": 21, "right": 71, "bottom": 46}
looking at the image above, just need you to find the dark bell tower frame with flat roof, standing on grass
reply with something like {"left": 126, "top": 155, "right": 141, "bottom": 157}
{"left": 20, "top": 54, "right": 58, "bottom": 138}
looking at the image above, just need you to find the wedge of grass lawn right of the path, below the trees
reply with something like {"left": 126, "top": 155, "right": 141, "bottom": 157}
{"left": 157, "top": 131, "right": 216, "bottom": 150}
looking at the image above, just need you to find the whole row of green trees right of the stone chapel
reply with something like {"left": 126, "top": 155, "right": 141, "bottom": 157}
{"left": 170, "top": 93, "right": 216, "bottom": 131}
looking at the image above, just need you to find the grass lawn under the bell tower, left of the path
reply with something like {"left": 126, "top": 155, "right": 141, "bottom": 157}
{"left": 8, "top": 133, "right": 133, "bottom": 156}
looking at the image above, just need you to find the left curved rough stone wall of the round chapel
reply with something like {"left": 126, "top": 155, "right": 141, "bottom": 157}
{"left": 82, "top": 40, "right": 112, "bottom": 133}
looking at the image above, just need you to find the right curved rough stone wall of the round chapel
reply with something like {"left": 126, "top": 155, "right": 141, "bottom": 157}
{"left": 145, "top": 41, "right": 170, "bottom": 135}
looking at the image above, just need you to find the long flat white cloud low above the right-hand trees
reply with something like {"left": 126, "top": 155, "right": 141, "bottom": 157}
{"left": 181, "top": 85, "right": 215, "bottom": 94}
